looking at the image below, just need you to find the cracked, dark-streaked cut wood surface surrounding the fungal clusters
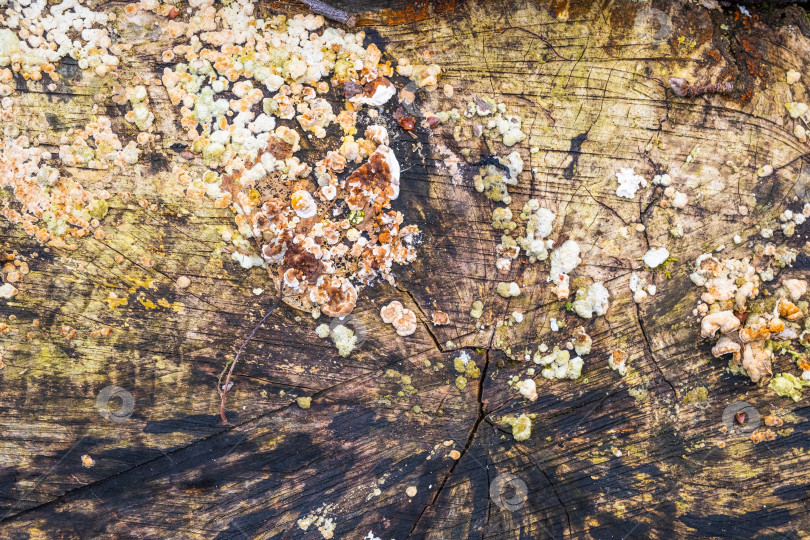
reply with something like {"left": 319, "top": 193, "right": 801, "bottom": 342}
{"left": 0, "top": 0, "right": 810, "bottom": 539}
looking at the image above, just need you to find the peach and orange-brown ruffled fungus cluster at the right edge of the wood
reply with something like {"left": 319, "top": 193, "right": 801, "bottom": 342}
{"left": 690, "top": 240, "right": 810, "bottom": 391}
